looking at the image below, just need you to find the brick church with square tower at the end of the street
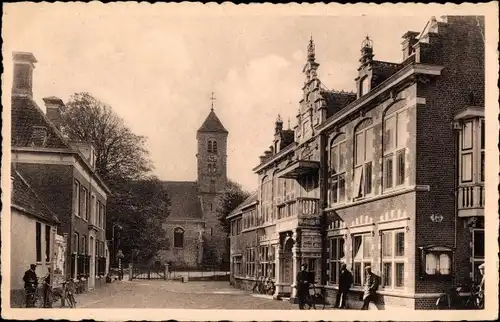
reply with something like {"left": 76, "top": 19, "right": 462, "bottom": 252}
{"left": 160, "top": 106, "right": 229, "bottom": 269}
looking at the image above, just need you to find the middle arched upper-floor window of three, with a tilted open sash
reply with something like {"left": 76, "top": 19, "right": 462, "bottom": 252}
{"left": 352, "top": 119, "right": 375, "bottom": 200}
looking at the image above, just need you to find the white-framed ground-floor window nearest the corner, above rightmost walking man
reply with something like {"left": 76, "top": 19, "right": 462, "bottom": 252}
{"left": 380, "top": 229, "right": 407, "bottom": 290}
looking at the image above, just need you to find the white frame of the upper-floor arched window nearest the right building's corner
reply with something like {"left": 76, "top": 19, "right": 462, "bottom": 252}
{"left": 382, "top": 107, "right": 409, "bottom": 192}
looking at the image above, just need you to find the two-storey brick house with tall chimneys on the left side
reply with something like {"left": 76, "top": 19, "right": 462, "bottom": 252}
{"left": 11, "top": 52, "right": 110, "bottom": 288}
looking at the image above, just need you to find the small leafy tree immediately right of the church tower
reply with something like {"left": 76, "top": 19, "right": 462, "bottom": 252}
{"left": 217, "top": 180, "right": 250, "bottom": 234}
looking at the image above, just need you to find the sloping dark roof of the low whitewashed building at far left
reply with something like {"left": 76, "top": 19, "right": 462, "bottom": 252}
{"left": 11, "top": 170, "right": 59, "bottom": 224}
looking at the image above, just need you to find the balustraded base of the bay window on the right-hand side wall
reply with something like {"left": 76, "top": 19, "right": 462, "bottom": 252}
{"left": 457, "top": 184, "right": 485, "bottom": 217}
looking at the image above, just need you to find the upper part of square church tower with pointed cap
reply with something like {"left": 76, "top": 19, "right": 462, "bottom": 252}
{"left": 196, "top": 97, "right": 229, "bottom": 197}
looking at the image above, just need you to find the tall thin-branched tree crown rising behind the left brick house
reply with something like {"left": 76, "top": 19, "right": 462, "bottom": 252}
{"left": 63, "top": 93, "right": 152, "bottom": 184}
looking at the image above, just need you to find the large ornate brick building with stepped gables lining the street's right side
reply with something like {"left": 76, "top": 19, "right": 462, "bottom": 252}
{"left": 231, "top": 16, "right": 485, "bottom": 309}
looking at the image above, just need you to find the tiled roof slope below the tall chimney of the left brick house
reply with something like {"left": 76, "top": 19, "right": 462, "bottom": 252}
{"left": 11, "top": 96, "right": 70, "bottom": 149}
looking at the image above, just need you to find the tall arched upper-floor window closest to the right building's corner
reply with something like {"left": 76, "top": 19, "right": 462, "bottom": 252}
{"left": 383, "top": 109, "right": 409, "bottom": 189}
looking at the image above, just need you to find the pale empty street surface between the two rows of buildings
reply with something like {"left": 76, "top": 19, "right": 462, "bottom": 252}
{"left": 76, "top": 280, "right": 297, "bottom": 310}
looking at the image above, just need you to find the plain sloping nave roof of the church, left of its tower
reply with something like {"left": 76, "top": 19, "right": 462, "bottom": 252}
{"left": 163, "top": 181, "right": 203, "bottom": 219}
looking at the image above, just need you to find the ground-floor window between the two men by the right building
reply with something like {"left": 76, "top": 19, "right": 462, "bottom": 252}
{"left": 352, "top": 233, "right": 373, "bottom": 286}
